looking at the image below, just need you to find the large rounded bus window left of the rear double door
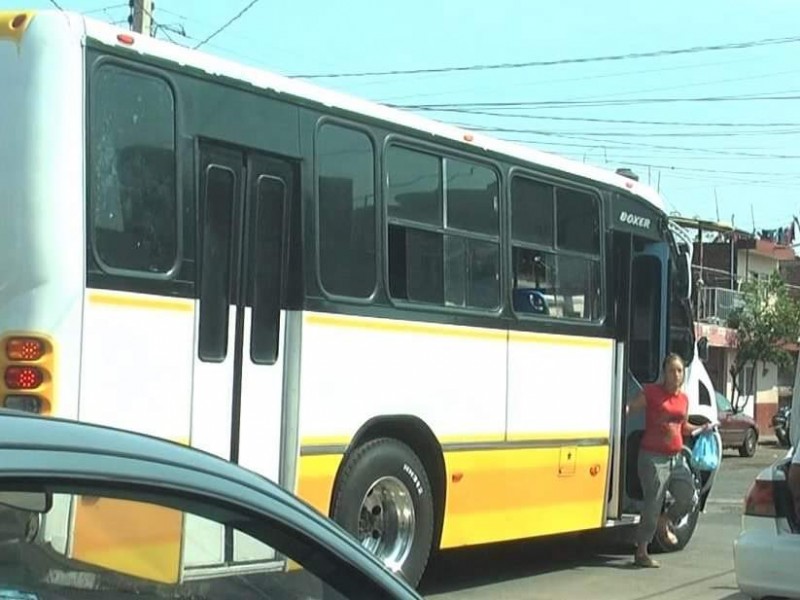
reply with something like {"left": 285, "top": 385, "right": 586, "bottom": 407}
{"left": 89, "top": 66, "right": 178, "bottom": 273}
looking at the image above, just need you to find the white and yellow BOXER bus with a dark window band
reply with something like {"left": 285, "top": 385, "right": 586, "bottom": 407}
{"left": 0, "top": 11, "right": 716, "bottom": 583}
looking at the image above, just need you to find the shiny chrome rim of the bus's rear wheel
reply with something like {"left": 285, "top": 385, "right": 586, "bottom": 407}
{"left": 358, "top": 477, "right": 416, "bottom": 572}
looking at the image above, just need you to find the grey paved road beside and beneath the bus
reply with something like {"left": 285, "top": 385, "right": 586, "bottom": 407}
{"left": 420, "top": 445, "right": 785, "bottom": 600}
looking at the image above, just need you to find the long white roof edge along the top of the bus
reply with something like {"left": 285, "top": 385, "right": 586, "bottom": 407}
{"left": 39, "top": 10, "right": 665, "bottom": 212}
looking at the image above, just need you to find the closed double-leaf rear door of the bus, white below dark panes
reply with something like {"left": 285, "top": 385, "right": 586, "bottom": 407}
{"left": 184, "top": 144, "right": 293, "bottom": 568}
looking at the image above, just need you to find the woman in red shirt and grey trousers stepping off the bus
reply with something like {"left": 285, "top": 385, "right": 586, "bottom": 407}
{"left": 630, "top": 354, "right": 711, "bottom": 567}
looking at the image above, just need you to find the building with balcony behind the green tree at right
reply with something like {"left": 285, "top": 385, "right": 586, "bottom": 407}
{"left": 673, "top": 217, "right": 800, "bottom": 434}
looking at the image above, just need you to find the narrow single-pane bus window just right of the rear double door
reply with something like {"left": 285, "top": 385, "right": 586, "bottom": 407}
{"left": 317, "top": 124, "right": 377, "bottom": 298}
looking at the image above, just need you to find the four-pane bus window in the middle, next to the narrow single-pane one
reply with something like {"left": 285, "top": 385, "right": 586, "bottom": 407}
{"left": 386, "top": 146, "right": 500, "bottom": 310}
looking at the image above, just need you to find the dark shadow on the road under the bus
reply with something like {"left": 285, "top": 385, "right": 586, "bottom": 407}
{"left": 420, "top": 533, "right": 640, "bottom": 596}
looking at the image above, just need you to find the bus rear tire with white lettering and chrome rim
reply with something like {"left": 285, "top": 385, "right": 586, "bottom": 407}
{"left": 331, "top": 438, "right": 434, "bottom": 587}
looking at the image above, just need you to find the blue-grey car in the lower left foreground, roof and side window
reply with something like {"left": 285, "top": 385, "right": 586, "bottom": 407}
{"left": 0, "top": 412, "right": 420, "bottom": 600}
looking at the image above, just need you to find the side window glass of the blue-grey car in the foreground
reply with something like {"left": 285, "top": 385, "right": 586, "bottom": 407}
{"left": 0, "top": 492, "right": 345, "bottom": 600}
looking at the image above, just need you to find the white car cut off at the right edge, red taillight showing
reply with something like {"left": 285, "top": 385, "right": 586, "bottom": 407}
{"left": 733, "top": 453, "right": 800, "bottom": 599}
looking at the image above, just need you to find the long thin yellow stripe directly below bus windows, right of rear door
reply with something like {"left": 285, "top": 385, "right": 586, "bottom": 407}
{"left": 306, "top": 313, "right": 614, "bottom": 350}
